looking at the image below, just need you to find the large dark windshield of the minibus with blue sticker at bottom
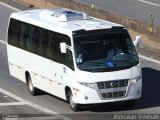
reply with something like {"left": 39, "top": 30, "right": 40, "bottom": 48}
{"left": 74, "top": 29, "right": 139, "bottom": 72}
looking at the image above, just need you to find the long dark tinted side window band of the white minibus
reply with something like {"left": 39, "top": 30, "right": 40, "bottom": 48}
{"left": 8, "top": 19, "right": 73, "bottom": 69}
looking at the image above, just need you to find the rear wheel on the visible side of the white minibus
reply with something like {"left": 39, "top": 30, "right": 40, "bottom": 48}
{"left": 28, "top": 75, "right": 38, "bottom": 96}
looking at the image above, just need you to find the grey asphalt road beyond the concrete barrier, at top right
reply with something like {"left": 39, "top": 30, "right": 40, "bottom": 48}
{"left": 75, "top": 0, "right": 160, "bottom": 26}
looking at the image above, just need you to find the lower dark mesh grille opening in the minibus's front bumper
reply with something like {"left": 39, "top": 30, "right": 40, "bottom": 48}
{"left": 101, "top": 91, "right": 126, "bottom": 98}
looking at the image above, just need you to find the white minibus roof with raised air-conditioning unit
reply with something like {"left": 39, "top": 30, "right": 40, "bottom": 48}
{"left": 11, "top": 8, "right": 123, "bottom": 32}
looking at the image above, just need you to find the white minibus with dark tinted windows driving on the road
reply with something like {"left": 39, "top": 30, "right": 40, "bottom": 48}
{"left": 7, "top": 8, "right": 142, "bottom": 111}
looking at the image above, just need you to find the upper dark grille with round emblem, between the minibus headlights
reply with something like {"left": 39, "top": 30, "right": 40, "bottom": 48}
{"left": 97, "top": 80, "right": 128, "bottom": 89}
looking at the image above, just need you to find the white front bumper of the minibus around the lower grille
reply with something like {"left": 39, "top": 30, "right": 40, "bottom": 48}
{"left": 73, "top": 80, "right": 142, "bottom": 104}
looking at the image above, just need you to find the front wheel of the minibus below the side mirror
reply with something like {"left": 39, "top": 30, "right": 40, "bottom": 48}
{"left": 68, "top": 91, "right": 80, "bottom": 112}
